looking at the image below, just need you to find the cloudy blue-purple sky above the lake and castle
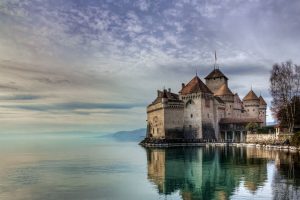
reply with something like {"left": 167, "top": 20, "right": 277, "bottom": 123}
{"left": 0, "top": 0, "right": 300, "bottom": 133}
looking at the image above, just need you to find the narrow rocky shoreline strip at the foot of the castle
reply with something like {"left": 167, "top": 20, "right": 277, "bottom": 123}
{"left": 140, "top": 142, "right": 300, "bottom": 152}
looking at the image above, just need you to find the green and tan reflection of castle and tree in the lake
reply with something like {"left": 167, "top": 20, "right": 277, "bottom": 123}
{"left": 147, "top": 147, "right": 300, "bottom": 200}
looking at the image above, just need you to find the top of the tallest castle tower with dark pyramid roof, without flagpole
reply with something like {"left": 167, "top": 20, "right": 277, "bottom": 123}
{"left": 205, "top": 69, "right": 228, "bottom": 93}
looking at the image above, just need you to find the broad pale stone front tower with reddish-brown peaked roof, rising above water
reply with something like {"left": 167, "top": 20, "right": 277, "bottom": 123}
{"left": 179, "top": 75, "right": 216, "bottom": 139}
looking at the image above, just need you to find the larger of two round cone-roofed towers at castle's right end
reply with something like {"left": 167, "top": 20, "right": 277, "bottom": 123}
{"left": 243, "top": 88, "right": 260, "bottom": 118}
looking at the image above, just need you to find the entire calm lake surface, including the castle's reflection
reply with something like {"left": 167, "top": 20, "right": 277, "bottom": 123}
{"left": 0, "top": 135, "right": 300, "bottom": 200}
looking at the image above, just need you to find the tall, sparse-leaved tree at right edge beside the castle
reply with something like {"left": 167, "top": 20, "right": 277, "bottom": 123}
{"left": 270, "top": 61, "right": 300, "bottom": 132}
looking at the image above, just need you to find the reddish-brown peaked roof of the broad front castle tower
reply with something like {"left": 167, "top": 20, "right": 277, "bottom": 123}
{"left": 179, "top": 75, "right": 212, "bottom": 95}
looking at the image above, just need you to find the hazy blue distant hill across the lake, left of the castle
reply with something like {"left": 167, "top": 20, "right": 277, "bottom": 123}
{"left": 106, "top": 128, "right": 146, "bottom": 142}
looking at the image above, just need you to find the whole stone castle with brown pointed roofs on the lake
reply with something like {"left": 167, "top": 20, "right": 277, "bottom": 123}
{"left": 146, "top": 68, "right": 267, "bottom": 142}
